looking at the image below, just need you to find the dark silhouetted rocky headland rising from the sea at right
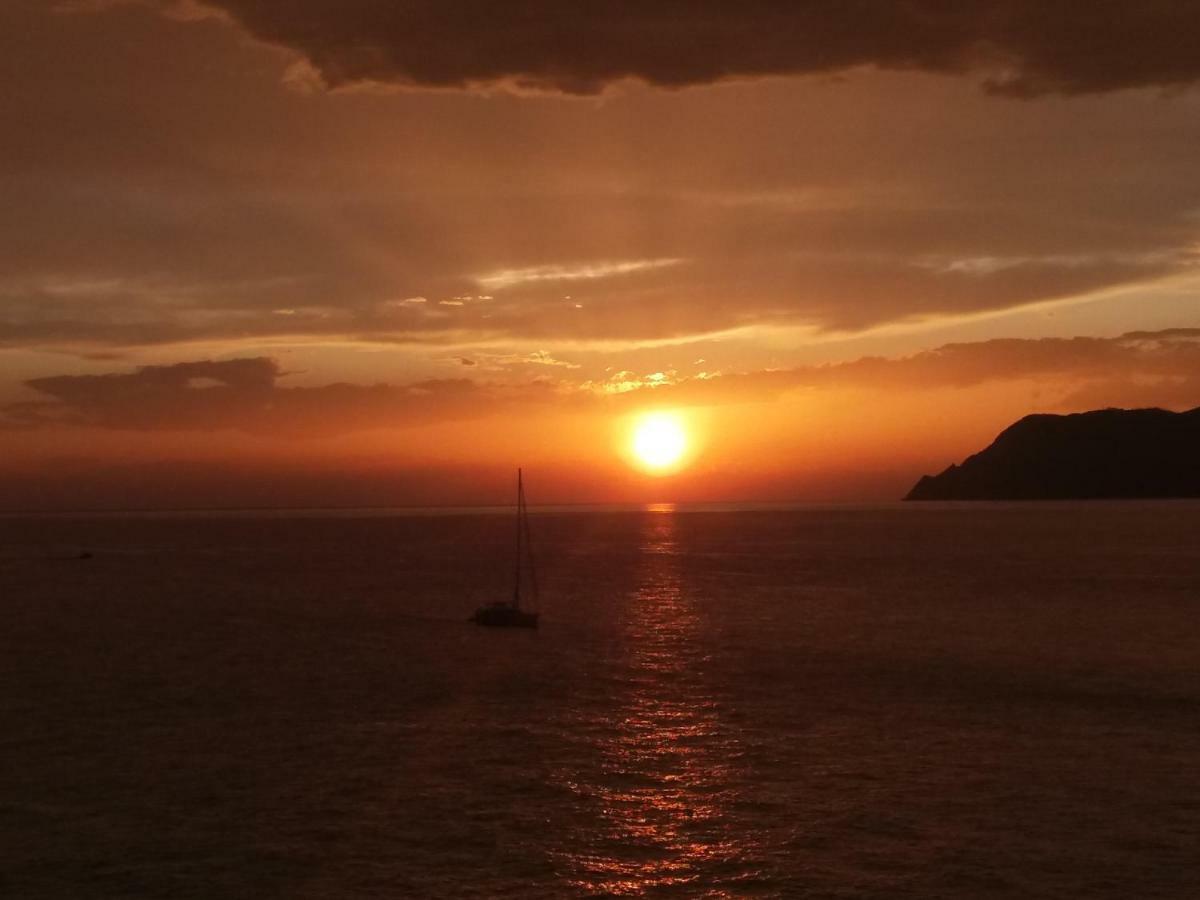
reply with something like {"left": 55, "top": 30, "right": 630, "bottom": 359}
{"left": 905, "top": 408, "right": 1200, "bottom": 500}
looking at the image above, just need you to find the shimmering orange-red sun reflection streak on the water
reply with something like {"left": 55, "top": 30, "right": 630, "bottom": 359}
{"left": 556, "top": 504, "right": 740, "bottom": 896}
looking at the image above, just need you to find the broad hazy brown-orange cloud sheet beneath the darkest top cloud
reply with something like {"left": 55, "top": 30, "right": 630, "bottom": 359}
{"left": 7, "top": 0, "right": 1200, "bottom": 352}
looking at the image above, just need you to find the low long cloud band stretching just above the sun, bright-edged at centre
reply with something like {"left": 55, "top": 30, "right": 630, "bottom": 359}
{"left": 11, "top": 329, "right": 1200, "bottom": 438}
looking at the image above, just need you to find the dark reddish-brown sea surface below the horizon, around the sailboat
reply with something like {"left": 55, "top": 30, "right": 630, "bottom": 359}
{"left": 0, "top": 503, "right": 1200, "bottom": 900}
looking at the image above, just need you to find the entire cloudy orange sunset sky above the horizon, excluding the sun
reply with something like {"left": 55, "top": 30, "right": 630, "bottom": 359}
{"left": 0, "top": 0, "right": 1200, "bottom": 509}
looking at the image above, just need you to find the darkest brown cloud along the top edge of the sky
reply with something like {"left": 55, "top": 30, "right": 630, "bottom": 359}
{"left": 180, "top": 0, "right": 1200, "bottom": 97}
